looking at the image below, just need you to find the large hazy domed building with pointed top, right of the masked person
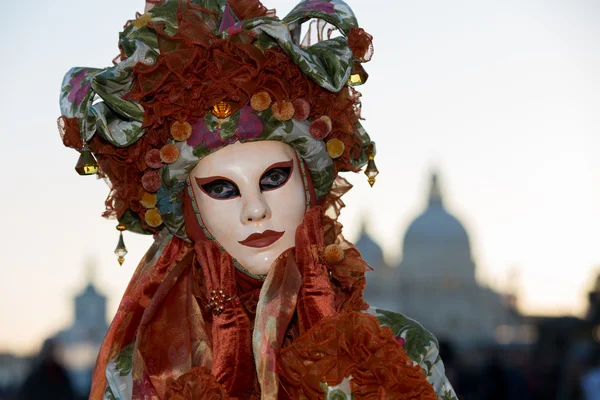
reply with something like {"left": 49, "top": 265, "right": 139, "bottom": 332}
{"left": 357, "top": 174, "right": 515, "bottom": 345}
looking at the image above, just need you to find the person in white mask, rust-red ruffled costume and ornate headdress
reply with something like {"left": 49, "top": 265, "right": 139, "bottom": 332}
{"left": 59, "top": 0, "right": 455, "bottom": 399}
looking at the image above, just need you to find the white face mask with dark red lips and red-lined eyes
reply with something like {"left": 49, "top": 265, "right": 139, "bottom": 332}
{"left": 190, "top": 140, "right": 306, "bottom": 275}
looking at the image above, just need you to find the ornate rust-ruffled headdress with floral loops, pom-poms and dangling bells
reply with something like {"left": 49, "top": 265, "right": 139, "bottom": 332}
{"left": 58, "top": 0, "right": 377, "bottom": 263}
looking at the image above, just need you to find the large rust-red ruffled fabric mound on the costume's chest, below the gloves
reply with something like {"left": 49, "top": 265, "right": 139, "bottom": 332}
{"left": 278, "top": 312, "right": 437, "bottom": 400}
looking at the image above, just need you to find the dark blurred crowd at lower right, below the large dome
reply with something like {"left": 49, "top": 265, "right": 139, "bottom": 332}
{"left": 440, "top": 340, "right": 600, "bottom": 400}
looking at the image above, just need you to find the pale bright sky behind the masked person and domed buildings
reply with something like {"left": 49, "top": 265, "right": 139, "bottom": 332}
{"left": 0, "top": 0, "right": 600, "bottom": 353}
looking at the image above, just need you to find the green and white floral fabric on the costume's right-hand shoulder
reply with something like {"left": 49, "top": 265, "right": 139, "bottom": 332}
{"left": 366, "top": 307, "right": 458, "bottom": 400}
